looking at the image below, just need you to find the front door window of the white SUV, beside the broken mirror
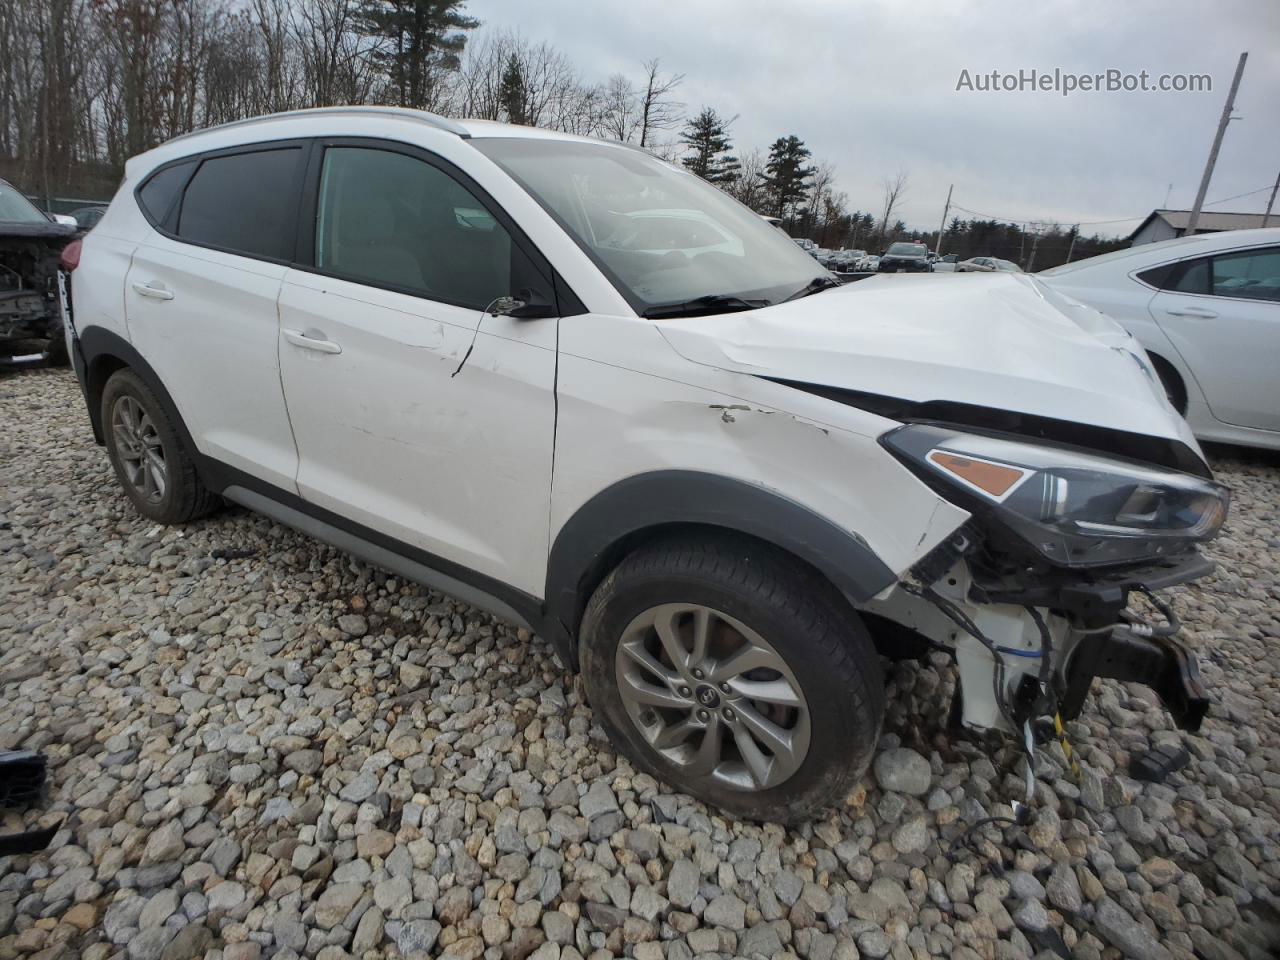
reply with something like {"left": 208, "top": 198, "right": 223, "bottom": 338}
{"left": 315, "top": 147, "right": 520, "bottom": 310}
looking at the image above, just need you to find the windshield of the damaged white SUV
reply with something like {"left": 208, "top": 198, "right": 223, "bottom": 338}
{"left": 471, "top": 138, "right": 823, "bottom": 312}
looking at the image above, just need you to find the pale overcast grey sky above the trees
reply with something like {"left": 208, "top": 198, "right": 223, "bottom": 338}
{"left": 466, "top": 0, "right": 1280, "bottom": 234}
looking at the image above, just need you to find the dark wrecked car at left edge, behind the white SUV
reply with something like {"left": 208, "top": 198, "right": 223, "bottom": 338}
{"left": 0, "top": 180, "right": 79, "bottom": 364}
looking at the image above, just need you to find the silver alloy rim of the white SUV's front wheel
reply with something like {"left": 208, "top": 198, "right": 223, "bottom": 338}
{"left": 614, "top": 603, "right": 810, "bottom": 790}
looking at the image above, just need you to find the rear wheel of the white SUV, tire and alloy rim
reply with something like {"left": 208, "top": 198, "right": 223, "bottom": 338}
{"left": 101, "top": 369, "right": 218, "bottom": 524}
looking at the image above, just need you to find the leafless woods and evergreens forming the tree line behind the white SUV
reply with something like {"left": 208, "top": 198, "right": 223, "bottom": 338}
{"left": 0, "top": 0, "right": 1121, "bottom": 265}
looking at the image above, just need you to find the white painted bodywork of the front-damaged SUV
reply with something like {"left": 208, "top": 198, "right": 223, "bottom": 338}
{"left": 72, "top": 109, "right": 1218, "bottom": 742}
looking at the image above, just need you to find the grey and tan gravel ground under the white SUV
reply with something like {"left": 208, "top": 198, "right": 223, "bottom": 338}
{"left": 0, "top": 371, "right": 1280, "bottom": 960}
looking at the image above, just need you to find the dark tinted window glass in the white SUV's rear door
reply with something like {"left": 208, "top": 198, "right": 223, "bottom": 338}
{"left": 178, "top": 147, "right": 302, "bottom": 260}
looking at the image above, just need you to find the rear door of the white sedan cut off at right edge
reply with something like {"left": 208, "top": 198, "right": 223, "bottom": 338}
{"left": 1148, "top": 247, "right": 1280, "bottom": 430}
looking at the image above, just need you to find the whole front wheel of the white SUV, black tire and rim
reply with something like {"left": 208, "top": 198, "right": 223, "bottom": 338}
{"left": 580, "top": 536, "right": 884, "bottom": 823}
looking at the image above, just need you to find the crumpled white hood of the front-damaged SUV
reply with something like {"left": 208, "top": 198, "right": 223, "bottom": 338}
{"left": 658, "top": 274, "right": 1199, "bottom": 453}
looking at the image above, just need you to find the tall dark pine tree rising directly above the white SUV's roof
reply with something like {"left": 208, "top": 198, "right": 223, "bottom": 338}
{"left": 361, "top": 0, "right": 480, "bottom": 108}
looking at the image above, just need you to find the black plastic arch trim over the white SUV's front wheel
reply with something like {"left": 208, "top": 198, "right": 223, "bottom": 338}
{"left": 547, "top": 470, "right": 897, "bottom": 660}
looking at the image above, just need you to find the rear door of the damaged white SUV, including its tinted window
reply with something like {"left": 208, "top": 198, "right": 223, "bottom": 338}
{"left": 124, "top": 142, "right": 307, "bottom": 493}
